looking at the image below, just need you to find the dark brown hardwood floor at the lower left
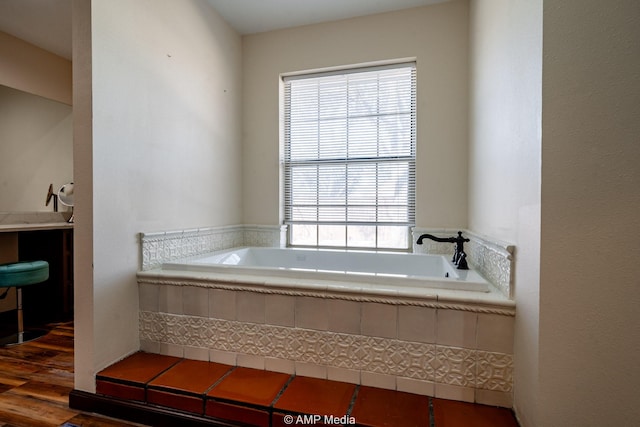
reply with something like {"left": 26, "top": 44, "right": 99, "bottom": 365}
{"left": 0, "top": 323, "right": 145, "bottom": 427}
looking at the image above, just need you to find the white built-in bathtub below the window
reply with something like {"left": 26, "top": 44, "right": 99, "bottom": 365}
{"left": 162, "top": 247, "right": 490, "bottom": 292}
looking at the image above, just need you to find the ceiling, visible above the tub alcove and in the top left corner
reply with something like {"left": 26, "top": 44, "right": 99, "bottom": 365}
{"left": 0, "top": 0, "right": 447, "bottom": 59}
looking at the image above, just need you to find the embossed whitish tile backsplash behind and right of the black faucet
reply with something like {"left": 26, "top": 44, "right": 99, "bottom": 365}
{"left": 412, "top": 228, "right": 515, "bottom": 298}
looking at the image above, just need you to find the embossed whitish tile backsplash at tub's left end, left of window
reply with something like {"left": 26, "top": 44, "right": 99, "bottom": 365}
{"left": 139, "top": 225, "right": 286, "bottom": 271}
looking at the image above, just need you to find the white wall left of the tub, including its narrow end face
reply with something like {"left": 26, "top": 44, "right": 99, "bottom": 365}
{"left": 74, "top": 0, "right": 242, "bottom": 391}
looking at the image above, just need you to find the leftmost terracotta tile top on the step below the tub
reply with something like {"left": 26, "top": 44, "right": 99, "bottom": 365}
{"left": 96, "top": 352, "right": 181, "bottom": 385}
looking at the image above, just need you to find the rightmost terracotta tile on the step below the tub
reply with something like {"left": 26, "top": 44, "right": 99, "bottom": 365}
{"left": 432, "top": 399, "right": 518, "bottom": 427}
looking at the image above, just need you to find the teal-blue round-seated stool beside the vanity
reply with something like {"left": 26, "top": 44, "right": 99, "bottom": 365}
{"left": 0, "top": 261, "right": 49, "bottom": 346}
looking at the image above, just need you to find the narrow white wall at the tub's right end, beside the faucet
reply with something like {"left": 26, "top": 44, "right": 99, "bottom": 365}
{"left": 469, "top": 0, "right": 544, "bottom": 427}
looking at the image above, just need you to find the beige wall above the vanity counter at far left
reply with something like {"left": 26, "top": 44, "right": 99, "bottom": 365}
{"left": 0, "top": 31, "right": 73, "bottom": 212}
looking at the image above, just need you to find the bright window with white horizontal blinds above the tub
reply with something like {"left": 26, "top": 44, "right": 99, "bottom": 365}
{"left": 284, "top": 63, "right": 416, "bottom": 249}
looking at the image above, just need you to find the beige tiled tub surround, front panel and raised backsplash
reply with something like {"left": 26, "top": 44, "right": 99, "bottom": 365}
{"left": 138, "top": 227, "right": 515, "bottom": 407}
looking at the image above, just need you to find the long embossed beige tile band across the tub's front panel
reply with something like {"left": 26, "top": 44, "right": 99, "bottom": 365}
{"left": 139, "top": 311, "right": 513, "bottom": 393}
